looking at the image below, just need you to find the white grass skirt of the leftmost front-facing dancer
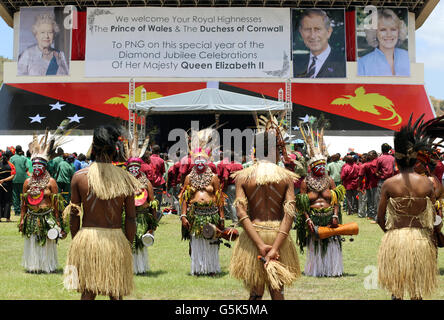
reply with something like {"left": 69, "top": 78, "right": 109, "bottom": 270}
{"left": 22, "top": 234, "right": 58, "bottom": 273}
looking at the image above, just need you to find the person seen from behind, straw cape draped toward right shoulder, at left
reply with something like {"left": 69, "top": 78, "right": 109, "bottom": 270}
{"left": 64, "top": 125, "right": 142, "bottom": 300}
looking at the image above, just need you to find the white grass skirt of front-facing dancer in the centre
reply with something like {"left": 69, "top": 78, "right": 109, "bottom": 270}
{"left": 190, "top": 235, "right": 221, "bottom": 275}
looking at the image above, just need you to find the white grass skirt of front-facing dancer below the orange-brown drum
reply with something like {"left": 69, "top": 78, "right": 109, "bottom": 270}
{"left": 304, "top": 236, "right": 344, "bottom": 277}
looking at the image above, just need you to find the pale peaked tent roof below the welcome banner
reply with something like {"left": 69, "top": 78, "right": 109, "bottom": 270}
{"left": 136, "top": 88, "right": 285, "bottom": 114}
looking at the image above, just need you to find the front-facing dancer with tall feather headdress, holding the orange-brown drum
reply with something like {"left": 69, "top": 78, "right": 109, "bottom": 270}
{"left": 296, "top": 117, "right": 345, "bottom": 277}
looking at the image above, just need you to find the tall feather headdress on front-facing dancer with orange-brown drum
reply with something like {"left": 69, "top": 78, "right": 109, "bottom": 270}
{"left": 299, "top": 114, "right": 330, "bottom": 167}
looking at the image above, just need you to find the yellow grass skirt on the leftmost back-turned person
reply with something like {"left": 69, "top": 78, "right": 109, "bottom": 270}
{"left": 64, "top": 228, "right": 134, "bottom": 297}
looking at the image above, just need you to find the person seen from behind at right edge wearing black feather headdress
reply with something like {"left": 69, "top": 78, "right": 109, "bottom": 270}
{"left": 377, "top": 115, "right": 444, "bottom": 300}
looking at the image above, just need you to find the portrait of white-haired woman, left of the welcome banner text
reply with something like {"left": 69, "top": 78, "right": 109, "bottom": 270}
{"left": 17, "top": 8, "right": 70, "bottom": 76}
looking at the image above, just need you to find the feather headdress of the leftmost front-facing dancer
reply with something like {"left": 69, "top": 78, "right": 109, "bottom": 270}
{"left": 28, "top": 119, "right": 72, "bottom": 162}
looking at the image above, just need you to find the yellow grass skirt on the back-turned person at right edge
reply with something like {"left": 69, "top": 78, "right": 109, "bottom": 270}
{"left": 378, "top": 228, "right": 438, "bottom": 298}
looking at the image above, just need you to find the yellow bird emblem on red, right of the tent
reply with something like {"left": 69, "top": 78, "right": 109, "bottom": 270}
{"left": 331, "top": 87, "right": 402, "bottom": 126}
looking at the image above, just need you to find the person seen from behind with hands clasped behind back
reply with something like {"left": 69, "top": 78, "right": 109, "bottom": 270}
{"left": 230, "top": 116, "right": 301, "bottom": 300}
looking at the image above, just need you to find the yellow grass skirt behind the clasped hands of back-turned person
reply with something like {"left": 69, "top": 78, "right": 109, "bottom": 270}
{"left": 230, "top": 221, "right": 301, "bottom": 290}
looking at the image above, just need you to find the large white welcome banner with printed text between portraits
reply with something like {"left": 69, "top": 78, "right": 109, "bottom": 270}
{"left": 85, "top": 7, "right": 291, "bottom": 78}
